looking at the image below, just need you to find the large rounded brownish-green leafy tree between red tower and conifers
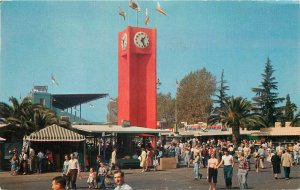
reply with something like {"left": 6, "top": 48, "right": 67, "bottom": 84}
{"left": 176, "top": 68, "right": 216, "bottom": 123}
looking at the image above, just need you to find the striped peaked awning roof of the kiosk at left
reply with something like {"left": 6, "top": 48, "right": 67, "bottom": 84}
{"left": 26, "top": 125, "right": 85, "bottom": 142}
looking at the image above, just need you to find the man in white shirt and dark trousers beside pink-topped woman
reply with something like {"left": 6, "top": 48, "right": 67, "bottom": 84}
{"left": 217, "top": 149, "right": 234, "bottom": 189}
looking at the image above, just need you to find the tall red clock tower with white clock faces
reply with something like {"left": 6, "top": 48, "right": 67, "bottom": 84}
{"left": 118, "top": 26, "right": 157, "bottom": 129}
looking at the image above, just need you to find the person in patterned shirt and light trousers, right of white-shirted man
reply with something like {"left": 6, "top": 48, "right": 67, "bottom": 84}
{"left": 237, "top": 152, "right": 250, "bottom": 189}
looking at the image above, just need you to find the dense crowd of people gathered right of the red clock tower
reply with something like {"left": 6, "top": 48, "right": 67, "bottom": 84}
{"left": 145, "top": 138, "right": 300, "bottom": 189}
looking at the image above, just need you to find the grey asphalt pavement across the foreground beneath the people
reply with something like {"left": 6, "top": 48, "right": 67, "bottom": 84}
{"left": 0, "top": 163, "right": 300, "bottom": 190}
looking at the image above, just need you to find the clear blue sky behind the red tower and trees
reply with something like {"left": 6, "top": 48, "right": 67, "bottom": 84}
{"left": 0, "top": 1, "right": 300, "bottom": 121}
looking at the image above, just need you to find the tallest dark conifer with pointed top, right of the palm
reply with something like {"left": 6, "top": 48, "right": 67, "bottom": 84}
{"left": 252, "top": 58, "right": 284, "bottom": 126}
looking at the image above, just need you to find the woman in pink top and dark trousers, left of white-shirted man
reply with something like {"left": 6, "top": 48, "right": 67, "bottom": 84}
{"left": 206, "top": 153, "right": 219, "bottom": 190}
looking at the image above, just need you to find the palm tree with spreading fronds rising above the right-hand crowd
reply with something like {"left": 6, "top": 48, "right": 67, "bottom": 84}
{"left": 208, "top": 96, "right": 263, "bottom": 145}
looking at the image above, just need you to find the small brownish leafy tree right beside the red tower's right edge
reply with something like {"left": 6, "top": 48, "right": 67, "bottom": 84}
{"left": 157, "top": 93, "right": 175, "bottom": 128}
